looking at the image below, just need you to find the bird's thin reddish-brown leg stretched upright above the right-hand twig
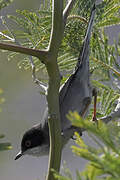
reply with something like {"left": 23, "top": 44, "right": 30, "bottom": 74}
{"left": 92, "top": 88, "right": 98, "bottom": 123}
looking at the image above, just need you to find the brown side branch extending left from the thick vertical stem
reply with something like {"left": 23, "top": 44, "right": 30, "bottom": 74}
{"left": 0, "top": 43, "right": 48, "bottom": 64}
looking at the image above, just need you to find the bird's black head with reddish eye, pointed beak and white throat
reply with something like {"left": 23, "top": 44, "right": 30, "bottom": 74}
{"left": 15, "top": 125, "right": 49, "bottom": 160}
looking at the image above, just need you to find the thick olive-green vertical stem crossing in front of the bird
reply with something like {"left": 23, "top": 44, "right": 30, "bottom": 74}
{"left": 46, "top": 0, "right": 64, "bottom": 180}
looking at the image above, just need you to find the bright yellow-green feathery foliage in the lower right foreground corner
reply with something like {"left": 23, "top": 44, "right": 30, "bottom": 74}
{"left": 55, "top": 112, "right": 120, "bottom": 180}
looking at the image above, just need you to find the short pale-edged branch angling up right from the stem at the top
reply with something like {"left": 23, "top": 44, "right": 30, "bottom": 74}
{"left": 63, "top": 0, "right": 76, "bottom": 24}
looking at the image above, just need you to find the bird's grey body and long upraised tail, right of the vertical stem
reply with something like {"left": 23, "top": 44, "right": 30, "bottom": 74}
{"left": 59, "top": 5, "right": 95, "bottom": 129}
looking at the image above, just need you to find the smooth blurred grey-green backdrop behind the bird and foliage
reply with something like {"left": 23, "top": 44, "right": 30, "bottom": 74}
{"left": 0, "top": 0, "right": 119, "bottom": 180}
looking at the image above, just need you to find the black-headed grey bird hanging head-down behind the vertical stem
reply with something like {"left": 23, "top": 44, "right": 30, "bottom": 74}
{"left": 15, "top": 4, "right": 96, "bottom": 160}
